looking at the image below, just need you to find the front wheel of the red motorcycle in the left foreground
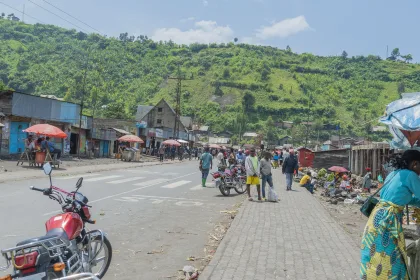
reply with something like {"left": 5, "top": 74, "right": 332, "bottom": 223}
{"left": 90, "top": 236, "right": 112, "bottom": 279}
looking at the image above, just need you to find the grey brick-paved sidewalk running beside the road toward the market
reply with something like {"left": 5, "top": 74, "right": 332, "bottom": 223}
{"left": 200, "top": 170, "right": 360, "bottom": 280}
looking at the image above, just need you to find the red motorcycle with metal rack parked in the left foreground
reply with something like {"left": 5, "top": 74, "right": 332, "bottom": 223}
{"left": 0, "top": 163, "right": 112, "bottom": 280}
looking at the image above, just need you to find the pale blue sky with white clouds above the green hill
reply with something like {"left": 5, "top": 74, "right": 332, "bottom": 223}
{"left": 0, "top": 0, "right": 420, "bottom": 61}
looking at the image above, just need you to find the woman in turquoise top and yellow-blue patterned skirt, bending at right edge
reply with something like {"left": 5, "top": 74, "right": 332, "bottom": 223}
{"left": 360, "top": 150, "right": 420, "bottom": 280}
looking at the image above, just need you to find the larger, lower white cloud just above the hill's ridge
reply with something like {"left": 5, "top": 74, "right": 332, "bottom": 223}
{"left": 152, "top": 20, "right": 234, "bottom": 44}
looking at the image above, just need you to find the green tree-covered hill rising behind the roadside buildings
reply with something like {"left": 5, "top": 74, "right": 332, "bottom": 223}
{"left": 0, "top": 19, "right": 420, "bottom": 144}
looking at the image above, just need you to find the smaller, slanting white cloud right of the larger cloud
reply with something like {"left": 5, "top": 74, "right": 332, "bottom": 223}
{"left": 256, "top": 16, "right": 312, "bottom": 40}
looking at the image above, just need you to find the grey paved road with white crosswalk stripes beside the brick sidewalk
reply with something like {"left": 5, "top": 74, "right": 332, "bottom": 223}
{"left": 0, "top": 161, "right": 242, "bottom": 279}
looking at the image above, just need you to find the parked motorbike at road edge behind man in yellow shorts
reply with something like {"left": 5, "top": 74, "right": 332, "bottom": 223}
{"left": 211, "top": 166, "right": 246, "bottom": 196}
